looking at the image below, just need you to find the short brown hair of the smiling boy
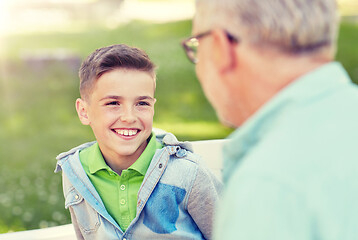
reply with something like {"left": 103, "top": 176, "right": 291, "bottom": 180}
{"left": 79, "top": 44, "right": 156, "bottom": 99}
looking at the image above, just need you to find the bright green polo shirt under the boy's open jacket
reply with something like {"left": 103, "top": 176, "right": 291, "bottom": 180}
{"left": 80, "top": 133, "right": 163, "bottom": 231}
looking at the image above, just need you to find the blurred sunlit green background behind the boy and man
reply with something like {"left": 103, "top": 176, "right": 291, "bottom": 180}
{"left": 0, "top": 0, "right": 358, "bottom": 233}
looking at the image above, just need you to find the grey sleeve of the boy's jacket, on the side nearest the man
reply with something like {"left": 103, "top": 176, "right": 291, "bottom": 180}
{"left": 187, "top": 160, "right": 222, "bottom": 239}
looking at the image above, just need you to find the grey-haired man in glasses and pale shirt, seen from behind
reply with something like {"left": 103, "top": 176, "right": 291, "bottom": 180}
{"left": 183, "top": 0, "right": 358, "bottom": 240}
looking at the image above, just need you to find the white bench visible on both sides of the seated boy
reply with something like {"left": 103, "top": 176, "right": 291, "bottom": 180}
{"left": 0, "top": 139, "right": 226, "bottom": 240}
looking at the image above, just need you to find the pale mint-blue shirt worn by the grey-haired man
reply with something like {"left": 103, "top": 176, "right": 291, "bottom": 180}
{"left": 215, "top": 62, "right": 358, "bottom": 240}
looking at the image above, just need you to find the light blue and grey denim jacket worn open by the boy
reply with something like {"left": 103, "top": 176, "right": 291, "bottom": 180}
{"left": 55, "top": 133, "right": 221, "bottom": 240}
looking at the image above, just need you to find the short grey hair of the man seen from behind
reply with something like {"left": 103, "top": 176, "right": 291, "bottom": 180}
{"left": 196, "top": 0, "right": 339, "bottom": 53}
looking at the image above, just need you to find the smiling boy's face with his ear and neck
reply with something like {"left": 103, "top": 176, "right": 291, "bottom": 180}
{"left": 76, "top": 69, "right": 156, "bottom": 164}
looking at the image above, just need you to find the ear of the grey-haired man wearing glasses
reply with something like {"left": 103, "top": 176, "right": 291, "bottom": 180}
{"left": 211, "top": 29, "right": 236, "bottom": 73}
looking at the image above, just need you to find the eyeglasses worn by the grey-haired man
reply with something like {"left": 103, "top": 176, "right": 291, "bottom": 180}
{"left": 181, "top": 30, "right": 239, "bottom": 64}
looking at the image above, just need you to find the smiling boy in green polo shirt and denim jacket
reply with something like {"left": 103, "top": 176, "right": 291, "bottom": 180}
{"left": 56, "top": 45, "right": 221, "bottom": 240}
